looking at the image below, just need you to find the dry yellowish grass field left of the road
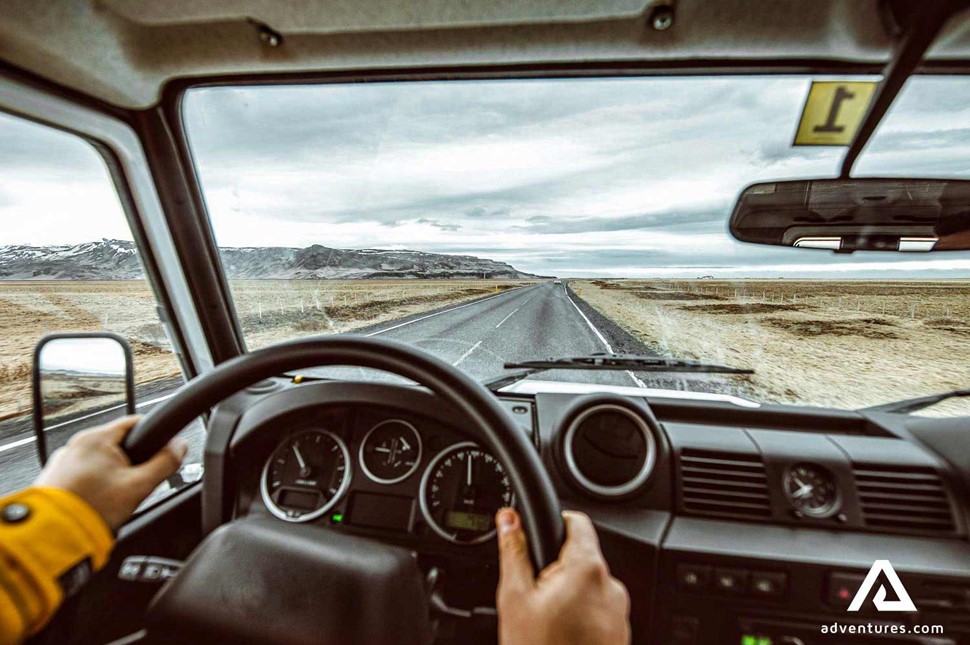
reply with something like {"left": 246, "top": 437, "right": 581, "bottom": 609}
{"left": 0, "top": 280, "right": 524, "bottom": 420}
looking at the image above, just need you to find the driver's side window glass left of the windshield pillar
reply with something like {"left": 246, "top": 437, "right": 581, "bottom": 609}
{"left": 0, "top": 114, "right": 202, "bottom": 498}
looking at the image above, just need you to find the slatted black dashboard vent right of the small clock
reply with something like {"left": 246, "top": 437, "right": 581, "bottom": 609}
{"left": 855, "top": 464, "right": 955, "bottom": 534}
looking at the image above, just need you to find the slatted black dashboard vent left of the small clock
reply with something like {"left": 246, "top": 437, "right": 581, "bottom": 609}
{"left": 680, "top": 449, "right": 771, "bottom": 520}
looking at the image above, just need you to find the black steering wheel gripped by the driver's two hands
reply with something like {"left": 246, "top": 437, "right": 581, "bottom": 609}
{"left": 123, "top": 335, "right": 565, "bottom": 643}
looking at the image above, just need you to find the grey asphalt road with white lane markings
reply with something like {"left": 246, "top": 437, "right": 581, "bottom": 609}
{"left": 0, "top": 282, "right": 648, "bottom": 494}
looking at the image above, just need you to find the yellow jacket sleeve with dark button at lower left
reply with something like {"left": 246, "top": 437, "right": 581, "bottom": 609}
{"left": 0, "top": 488, "right": 114, "bottom": 645}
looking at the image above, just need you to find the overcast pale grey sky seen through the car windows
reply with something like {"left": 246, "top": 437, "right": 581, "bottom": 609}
{"left": 0, "top": 77, "right": 970, "bottom": 277}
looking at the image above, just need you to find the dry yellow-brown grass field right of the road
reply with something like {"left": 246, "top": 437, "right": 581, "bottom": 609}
{"left": 570, "top": 280, "right": 970, "bottom": 408}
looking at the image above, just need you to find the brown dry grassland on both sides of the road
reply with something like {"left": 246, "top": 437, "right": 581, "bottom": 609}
{"left": 0, "top": 280, "right": 970, "bottom": 420}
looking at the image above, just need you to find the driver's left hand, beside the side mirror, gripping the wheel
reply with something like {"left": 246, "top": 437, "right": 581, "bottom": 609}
{"left": 34, "top": 416, "right": 188, "bottom": 531}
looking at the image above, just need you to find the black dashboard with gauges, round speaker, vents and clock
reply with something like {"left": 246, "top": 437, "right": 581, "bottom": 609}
{"left": 214, "top": 379, "right": 970, "bottom": 645}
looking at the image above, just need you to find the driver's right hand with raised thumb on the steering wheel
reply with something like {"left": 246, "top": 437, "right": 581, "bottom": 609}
{"left": 495, "top": 508, "right": 630, "bottom": 645}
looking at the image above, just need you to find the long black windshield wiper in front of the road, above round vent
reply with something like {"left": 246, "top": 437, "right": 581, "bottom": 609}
{"left": 485, "top": 354, "right": 754, "bottom": 392}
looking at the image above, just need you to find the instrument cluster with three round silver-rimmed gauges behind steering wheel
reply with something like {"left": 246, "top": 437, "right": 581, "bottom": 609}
{"left": 259, "top": 412, "right": 515, "bottom": 545}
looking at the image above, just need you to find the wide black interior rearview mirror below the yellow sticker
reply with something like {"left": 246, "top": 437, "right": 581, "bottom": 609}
{"left": 730, "top": 179, "right": 970, "bottom": 253}
